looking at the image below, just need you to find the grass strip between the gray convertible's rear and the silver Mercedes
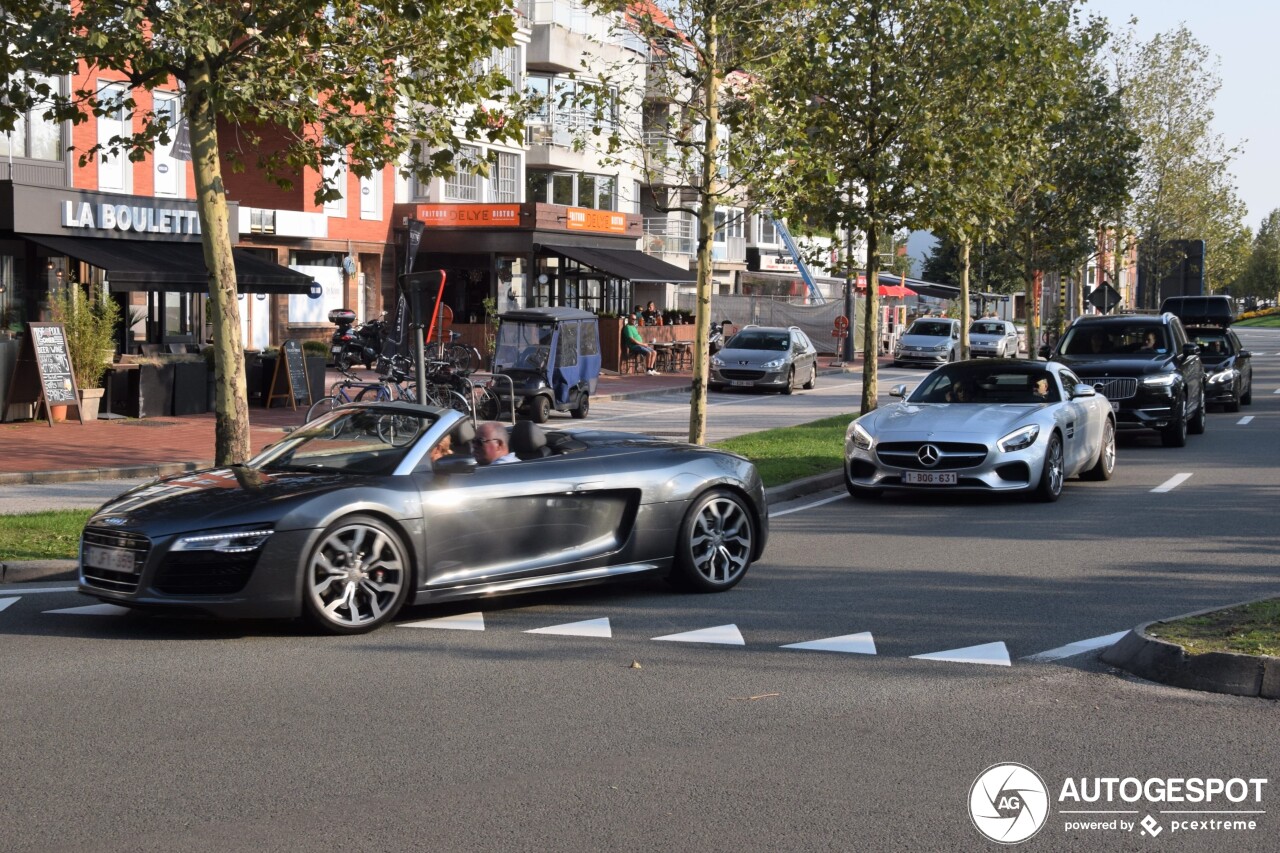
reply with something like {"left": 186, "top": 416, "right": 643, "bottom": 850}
{"left": 713, "top": 415, "right": 856, "bottom": 488}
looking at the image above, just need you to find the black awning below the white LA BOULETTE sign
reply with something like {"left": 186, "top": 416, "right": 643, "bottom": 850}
{"left": 27, "top": 234, "right": 311, "bottom": 295}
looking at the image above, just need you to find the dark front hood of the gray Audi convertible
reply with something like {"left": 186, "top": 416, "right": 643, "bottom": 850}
{"left": 90, "top": 466, "right": 374, "bottom": 537}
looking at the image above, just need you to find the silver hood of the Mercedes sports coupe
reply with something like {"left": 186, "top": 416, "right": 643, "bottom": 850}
{"left": 858, "top": 402, "right": 1050, "bottom": 442}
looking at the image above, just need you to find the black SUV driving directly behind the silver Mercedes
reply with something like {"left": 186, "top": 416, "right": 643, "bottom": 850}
{"left": 1053, "top": 314, "right": 1204, "bottom": 447}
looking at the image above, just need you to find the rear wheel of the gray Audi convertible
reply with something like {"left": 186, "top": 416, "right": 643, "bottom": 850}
{"left": 671, "top": 489, "right": 755, "bottom": 592}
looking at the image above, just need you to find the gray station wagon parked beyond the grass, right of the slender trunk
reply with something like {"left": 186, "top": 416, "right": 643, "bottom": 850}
{"left": 707, "top": 325, "right": 818, "bottom": 394}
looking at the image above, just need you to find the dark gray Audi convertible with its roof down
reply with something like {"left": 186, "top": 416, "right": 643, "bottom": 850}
{"left": 79, "top": 403, "right": 768, "bottom": 634}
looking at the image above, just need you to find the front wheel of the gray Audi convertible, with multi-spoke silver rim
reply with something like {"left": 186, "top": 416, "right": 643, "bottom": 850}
{"left": 302, "top": 515, "right": 413, "bottom": 634}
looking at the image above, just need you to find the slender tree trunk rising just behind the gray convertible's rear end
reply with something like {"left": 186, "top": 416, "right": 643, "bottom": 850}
{"left": 689, "top": 10, "right": 721, "bottom": 444}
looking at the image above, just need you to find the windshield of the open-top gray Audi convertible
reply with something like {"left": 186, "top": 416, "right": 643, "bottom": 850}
{"left": 246, "top": 406, "right": 436, "bottom": 475}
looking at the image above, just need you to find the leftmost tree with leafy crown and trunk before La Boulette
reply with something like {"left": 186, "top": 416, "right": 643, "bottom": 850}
{"left": 0, "top": 0, "right": 521, "bottom": 465}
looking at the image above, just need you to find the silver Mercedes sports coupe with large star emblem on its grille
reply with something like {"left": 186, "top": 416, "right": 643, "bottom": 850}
{"left": 845, "top": 360, "right": 1116, "bottom": 501}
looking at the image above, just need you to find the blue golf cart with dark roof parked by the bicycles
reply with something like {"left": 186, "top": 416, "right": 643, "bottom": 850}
{"left": 493, "top": 307, "right": 600, "bottom": 424}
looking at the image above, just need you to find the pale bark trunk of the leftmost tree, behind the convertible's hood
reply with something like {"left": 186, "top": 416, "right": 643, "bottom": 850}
{"left": 187, "top": 63, "right": 252, "bottom": 465}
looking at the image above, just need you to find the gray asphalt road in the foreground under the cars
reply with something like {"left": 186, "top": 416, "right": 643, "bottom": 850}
{"left": 0, "top": 329, "right": 1280, "bottom": 850}
